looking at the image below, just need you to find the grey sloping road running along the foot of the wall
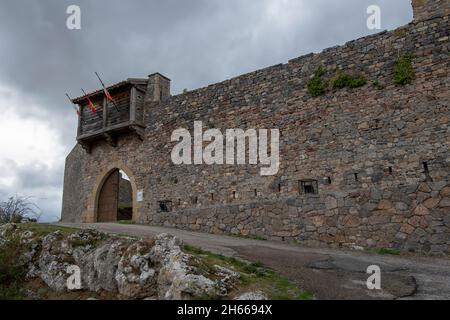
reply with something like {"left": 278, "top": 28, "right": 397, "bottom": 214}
{"left": 59, "top": 223, "right": 450, "bottom": 300}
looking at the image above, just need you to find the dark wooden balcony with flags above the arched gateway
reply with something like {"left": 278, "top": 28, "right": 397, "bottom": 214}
{"left": 73, "top": 79, "right": 147, "bottom": 153}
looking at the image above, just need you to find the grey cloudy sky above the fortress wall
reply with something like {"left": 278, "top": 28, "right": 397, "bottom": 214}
{"left": 0, "top": 0, "right": 412, "bottom": 221}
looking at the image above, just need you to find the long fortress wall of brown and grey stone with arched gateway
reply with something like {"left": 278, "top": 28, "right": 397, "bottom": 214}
{"left": 63, "top": 1, "right": 450, "bottom": 253}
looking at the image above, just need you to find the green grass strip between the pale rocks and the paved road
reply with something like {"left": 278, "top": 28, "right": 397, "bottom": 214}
{"left": 183, "top": 245, "right": 314, "bottom": 300}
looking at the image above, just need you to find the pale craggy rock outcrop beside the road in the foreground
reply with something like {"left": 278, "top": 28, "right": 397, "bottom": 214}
{"left": 0, "top": 224, "right": 239, "bottom": 300}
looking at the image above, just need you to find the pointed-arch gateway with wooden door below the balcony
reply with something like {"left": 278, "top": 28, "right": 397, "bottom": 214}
{"left": 97, "top": 169, "right": 133, "bottom": 222}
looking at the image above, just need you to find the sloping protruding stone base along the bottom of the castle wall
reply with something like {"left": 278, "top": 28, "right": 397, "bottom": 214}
{"left": 145, "top": 183, "right": 450, "bottom": 254}
